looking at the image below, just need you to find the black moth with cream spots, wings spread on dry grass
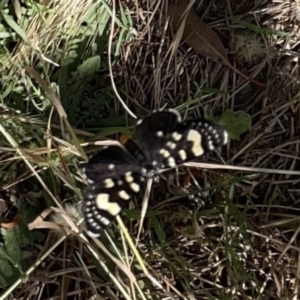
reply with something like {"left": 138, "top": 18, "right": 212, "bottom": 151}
{"left": 82, "top": 110, "right": 228, "bottom": 237}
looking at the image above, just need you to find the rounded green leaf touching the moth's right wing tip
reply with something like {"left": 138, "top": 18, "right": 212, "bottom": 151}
{"left": 218, "top": 109, "right": 252, "bottom": 140}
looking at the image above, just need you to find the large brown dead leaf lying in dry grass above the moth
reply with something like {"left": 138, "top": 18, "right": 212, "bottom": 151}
{"left": 169, "top": 2, "right": 228, "bottom": 61}
